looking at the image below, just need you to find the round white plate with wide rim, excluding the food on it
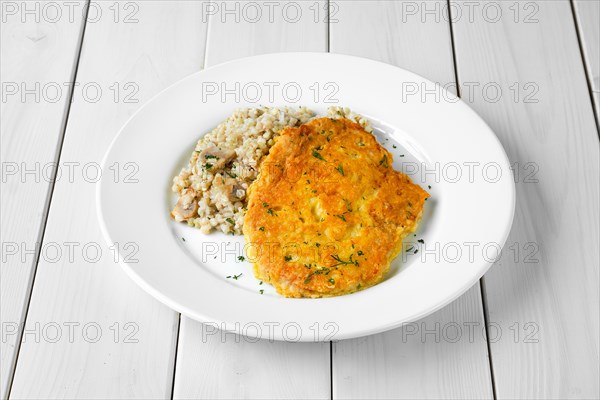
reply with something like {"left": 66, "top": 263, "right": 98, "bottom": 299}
{"left": 97, "top": 53, "right": 515, "bottom": 341}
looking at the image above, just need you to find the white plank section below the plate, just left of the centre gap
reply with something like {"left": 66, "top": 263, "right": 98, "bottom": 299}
{"left": 173, "top": 317, "right": 330, "bottom": 399}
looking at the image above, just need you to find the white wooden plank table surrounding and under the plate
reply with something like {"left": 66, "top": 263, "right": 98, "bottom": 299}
{"left": 0, "top": 0, "right": 600, "bottom": 399}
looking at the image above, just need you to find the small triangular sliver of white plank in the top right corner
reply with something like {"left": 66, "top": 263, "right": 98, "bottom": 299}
{"left": 573, "top": 0, "right": 600, "bottom": 116}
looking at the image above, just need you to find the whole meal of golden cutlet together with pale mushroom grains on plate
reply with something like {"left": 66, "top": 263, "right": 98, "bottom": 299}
{"left": 171, "top": 107, "right": 429, "bottom": 297}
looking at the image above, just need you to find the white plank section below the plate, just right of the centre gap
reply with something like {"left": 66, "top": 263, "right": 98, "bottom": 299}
{"left": 333, "top": 285, "right": 492, "bottom": 399}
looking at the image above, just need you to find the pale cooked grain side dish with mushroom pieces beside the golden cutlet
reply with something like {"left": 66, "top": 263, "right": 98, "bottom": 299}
{"left": 171, "top": 107, "right": 314, "bottom": 234}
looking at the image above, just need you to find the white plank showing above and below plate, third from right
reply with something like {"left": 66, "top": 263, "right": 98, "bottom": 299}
{"left": 330, "top": 1, "right": 492, "bottom": 399}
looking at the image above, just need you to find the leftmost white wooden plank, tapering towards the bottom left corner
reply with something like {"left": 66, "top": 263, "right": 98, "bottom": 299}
{"left": 0, "top": 1, "right": 86, "bottom": 398}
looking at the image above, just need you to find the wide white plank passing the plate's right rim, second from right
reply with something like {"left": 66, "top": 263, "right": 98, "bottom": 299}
{"left": 452, "top": 1, "right": 600, "bottom": 399}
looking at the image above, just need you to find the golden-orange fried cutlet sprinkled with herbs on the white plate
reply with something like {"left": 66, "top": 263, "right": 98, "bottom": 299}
{"left": 244, "top": 118, "right": 429, "bottom": 297}
